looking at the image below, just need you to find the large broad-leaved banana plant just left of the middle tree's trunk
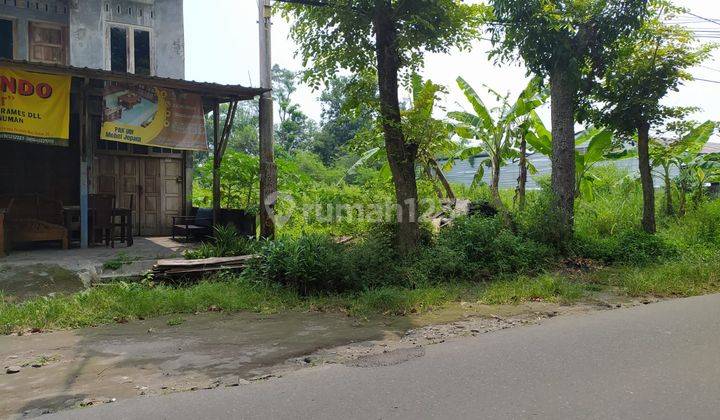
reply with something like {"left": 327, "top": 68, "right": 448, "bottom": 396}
{"left": 448, "top": 77, "right": 545, "bottom": 208}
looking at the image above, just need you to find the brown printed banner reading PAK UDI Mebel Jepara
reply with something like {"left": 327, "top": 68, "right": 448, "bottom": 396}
{"left": 100, "top": 82, "right": 208, "bottom": 151}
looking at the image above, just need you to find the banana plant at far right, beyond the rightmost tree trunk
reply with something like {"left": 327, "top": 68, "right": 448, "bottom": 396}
{"left": 650, "top": 121, "right": 717, "bottom": 215}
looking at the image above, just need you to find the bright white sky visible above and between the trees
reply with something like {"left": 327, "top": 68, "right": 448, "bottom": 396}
{"left": 184, "top": 0, "right": 720, "bottom": 134}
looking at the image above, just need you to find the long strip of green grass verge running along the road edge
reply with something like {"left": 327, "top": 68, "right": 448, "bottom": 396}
{"left": 0, "top": 258, "right": 720, "bottom": 334}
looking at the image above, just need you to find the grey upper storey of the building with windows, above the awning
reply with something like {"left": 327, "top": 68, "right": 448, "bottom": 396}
{"left": 0, "top": 0, "right": 185, "bottom": 79}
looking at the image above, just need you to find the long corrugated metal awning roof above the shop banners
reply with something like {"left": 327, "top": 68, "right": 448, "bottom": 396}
{"left": 0, "top": 59, "right": 269, "bottom": 101}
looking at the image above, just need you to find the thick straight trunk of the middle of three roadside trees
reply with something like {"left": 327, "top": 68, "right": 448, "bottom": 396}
{"left": 550, "top": 63, "right": 577, "bottom": 245}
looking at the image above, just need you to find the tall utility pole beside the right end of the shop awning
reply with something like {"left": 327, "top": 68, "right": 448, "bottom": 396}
{"left": 257, "top": 0, "right": 277, "bottom": 238}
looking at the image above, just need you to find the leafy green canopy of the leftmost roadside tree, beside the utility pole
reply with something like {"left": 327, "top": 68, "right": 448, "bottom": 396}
{"left": 280, "top": 0, "right": 487, "bottom": 87}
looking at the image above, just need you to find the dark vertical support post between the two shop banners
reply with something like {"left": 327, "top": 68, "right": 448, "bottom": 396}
{"left": 78, "top": 78, "right": 92, "bottom": 249}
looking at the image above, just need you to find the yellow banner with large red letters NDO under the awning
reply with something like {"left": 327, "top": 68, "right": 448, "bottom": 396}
{"left": 0, "top": 67, "right": 71, "bottom": 146}
